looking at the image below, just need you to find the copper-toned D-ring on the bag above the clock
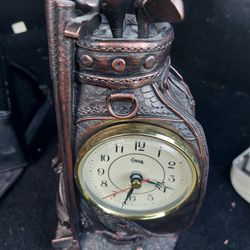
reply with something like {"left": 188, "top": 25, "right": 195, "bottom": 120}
{"left": 107, "top": 93, "right": 139, "bottom": 119}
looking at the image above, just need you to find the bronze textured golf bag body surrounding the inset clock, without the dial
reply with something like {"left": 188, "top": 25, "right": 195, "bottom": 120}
{"left": 46, "top": 0, "right": 208, "bottom": 249}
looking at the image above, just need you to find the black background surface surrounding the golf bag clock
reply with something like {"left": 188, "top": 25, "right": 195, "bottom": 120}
{"left": 0, "top": 0, "right": 250, "bottom": 250}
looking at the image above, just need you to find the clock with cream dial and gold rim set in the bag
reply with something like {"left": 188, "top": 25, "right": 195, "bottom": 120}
{"left": 76, "top": 124, "right": 198, "bottom": 219}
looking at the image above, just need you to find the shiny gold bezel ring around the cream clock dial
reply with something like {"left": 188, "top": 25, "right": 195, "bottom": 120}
{"left": 75, "top": 123, "right": 201, "bottom": 220}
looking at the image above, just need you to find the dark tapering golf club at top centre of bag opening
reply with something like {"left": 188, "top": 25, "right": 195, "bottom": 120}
{"left": 101, "top": 0, "right": 132, "bottom": 38}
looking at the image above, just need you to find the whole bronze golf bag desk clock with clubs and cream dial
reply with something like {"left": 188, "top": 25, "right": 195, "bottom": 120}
{"left": 46, "top": 0, "right": 208, "bottom": 250}
